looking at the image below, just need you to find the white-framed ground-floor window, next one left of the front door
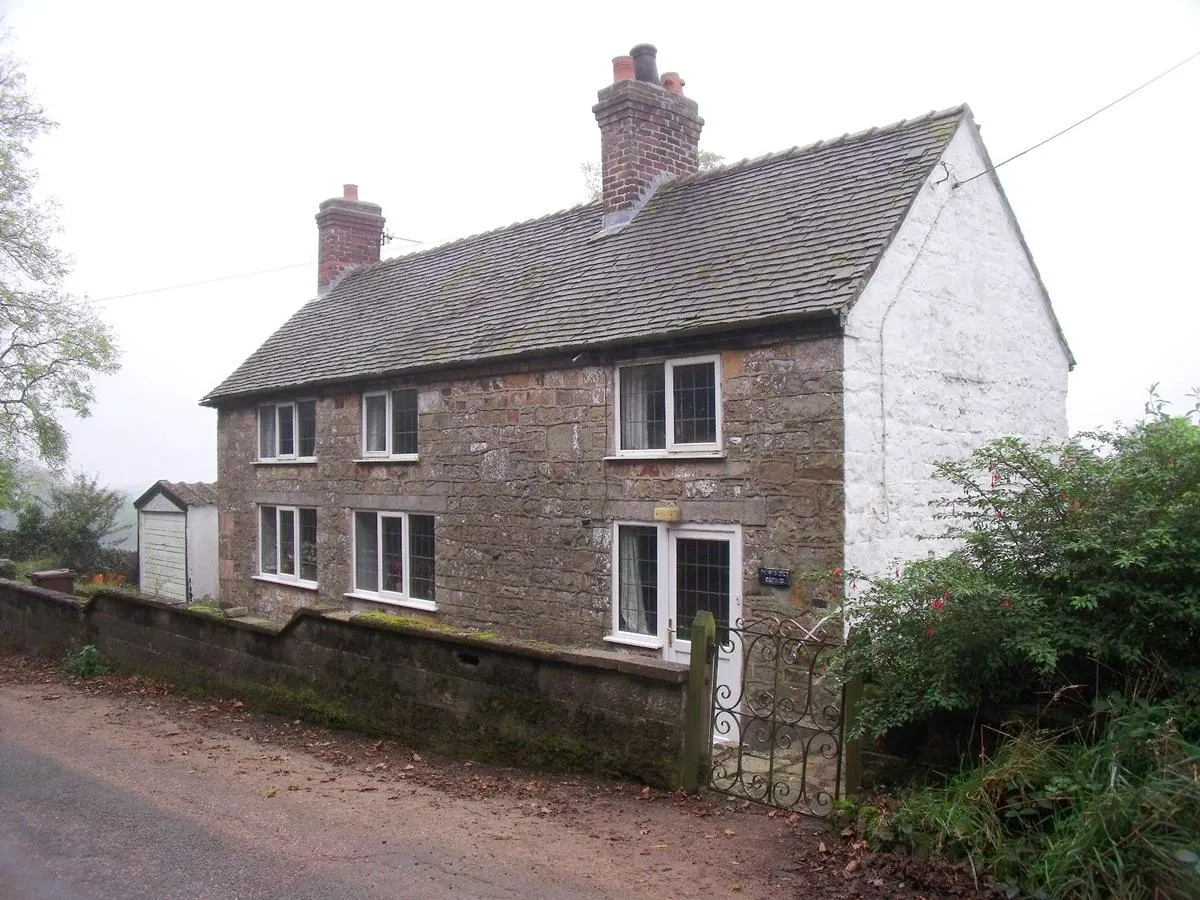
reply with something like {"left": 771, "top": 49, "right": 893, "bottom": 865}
{"left": 353, "top": 510, "right": 437, "bottom": 610}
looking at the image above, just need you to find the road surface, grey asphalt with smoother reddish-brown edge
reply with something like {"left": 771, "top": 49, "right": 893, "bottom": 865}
{"left": 0, "top": 688, "right": 617, "bottom": 900}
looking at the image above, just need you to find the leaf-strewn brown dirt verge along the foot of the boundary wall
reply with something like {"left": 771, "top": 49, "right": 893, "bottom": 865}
{"left": 0, "top": 656, "right": 998, "bottom": 900}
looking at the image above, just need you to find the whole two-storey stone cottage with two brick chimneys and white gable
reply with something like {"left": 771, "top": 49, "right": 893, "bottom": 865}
{"left": 203, "top": 44, "right": 1073, "bottom": 696}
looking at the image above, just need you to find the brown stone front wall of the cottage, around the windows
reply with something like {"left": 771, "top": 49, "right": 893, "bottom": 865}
{"left": 218, "top": 329, "right": 844, "bottom": 646}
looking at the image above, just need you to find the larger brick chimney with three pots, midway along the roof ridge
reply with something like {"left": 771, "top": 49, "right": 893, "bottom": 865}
{"left": 592, "top": 43, "right": 704, "bottom": 228}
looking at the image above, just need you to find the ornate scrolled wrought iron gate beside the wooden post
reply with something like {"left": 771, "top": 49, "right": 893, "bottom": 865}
{"left": 709, "top": 616, "right": 845, "bottom": 817}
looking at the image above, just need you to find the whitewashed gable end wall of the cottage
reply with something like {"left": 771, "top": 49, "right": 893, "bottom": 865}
{"left": 844, "top": 121, "right": 1069, "bottom": 572}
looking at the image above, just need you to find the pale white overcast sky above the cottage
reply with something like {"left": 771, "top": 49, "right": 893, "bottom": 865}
{"left": 0, "top": 0, "right": 1200, "bottom": 487}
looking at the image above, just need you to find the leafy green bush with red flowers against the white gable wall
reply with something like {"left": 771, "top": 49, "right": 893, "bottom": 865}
{"left": 835, "top": 403, "right": 1200, "bottom": 736}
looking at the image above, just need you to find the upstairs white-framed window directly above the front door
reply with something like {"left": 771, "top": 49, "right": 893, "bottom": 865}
{"left": 616, "top": 355, "right": 721, "bottom": 456}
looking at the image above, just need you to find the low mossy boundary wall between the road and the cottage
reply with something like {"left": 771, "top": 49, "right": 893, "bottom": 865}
{"left": 0, "top": 580, "right": 688, "bottom": 787}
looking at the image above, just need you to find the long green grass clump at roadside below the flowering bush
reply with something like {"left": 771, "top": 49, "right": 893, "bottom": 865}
{"left": 870, "top": 702, "right": 1200, "bottom": 900}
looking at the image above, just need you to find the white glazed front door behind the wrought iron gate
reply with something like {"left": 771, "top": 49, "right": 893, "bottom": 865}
{"left": 665, "top": 526, "right": 742, "bottom": 724}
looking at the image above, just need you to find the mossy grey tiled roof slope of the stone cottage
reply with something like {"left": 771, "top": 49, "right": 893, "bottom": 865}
{"left": 202, "top": 106, "right": 971, "bottom": 406}
